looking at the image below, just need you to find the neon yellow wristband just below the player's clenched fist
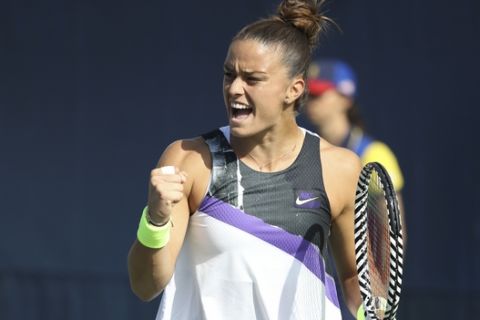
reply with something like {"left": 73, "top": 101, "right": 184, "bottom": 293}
{"left": 137, "top": 206, "right": 172, "bottom": 249}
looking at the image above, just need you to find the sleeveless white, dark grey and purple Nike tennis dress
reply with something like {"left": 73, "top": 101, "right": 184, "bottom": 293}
{"left": 156, "top": 127, "right": 341, "bottom": 320}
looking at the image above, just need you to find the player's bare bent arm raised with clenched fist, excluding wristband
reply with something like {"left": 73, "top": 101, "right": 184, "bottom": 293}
{"left": 128, "top": 139, "right": 209, "bottom": 301}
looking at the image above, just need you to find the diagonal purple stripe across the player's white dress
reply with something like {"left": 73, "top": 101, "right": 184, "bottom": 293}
{"left": 199, "top": 196, "right": 339, "bottom": 307}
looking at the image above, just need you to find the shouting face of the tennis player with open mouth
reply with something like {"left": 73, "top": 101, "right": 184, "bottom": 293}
{"left": 223, "top": 40, "right": 303, "bottom": 137}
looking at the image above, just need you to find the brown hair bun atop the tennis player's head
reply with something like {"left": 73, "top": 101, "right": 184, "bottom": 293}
{"left": 277, "top": 0, "right": 330, "bottom": 48}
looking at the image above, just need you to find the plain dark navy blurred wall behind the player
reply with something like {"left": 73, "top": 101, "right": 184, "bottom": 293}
{"left": 0, "top": 0, "right": 480, "bottom": 319}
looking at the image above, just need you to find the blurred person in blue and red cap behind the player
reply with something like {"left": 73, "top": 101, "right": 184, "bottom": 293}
{"left": 305, "top": 59, "right": 407, "bottom": 319}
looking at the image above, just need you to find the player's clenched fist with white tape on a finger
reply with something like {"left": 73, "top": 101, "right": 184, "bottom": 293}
{"left": 148, "top": 166, "right": 187, "bottom": 225}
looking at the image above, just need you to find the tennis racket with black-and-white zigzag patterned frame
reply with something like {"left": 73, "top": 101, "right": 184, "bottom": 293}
{"left": 355, "top": 162, "right": 403, "bottom": 320}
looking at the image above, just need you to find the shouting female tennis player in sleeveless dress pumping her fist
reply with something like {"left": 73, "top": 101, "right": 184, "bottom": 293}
{"left": 128, "top": 0, "right": 361, "bottom": 320}
